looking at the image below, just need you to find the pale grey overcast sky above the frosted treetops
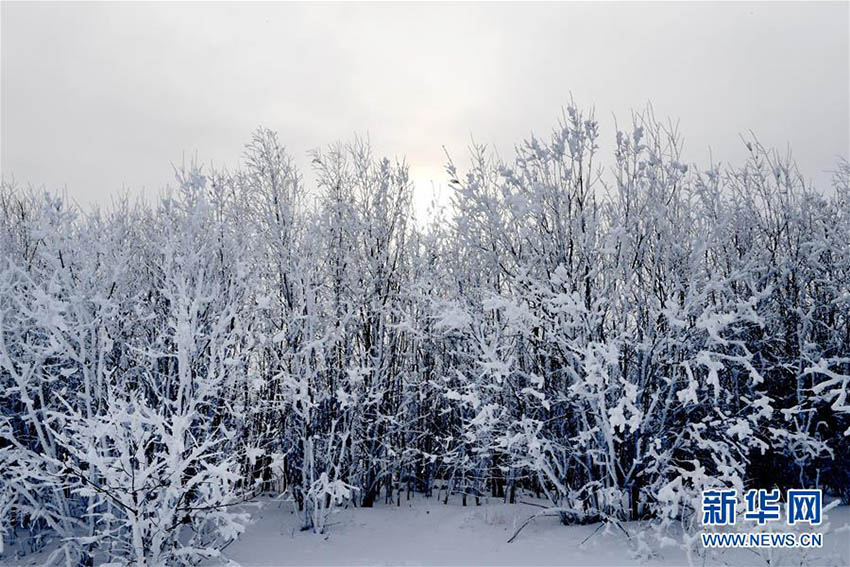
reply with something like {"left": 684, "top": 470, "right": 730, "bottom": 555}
{"left": 0, "top": 2, "right": 850, "bottom": 215}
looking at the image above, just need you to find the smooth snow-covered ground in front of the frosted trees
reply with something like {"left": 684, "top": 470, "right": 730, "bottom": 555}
{"left": 210, "top": 497, "right": 850, "bottom": 567}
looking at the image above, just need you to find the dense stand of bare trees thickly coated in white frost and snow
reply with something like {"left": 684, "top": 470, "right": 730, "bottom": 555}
{"left": 0, "top": 105, "right": 850, "bottom": 565}
